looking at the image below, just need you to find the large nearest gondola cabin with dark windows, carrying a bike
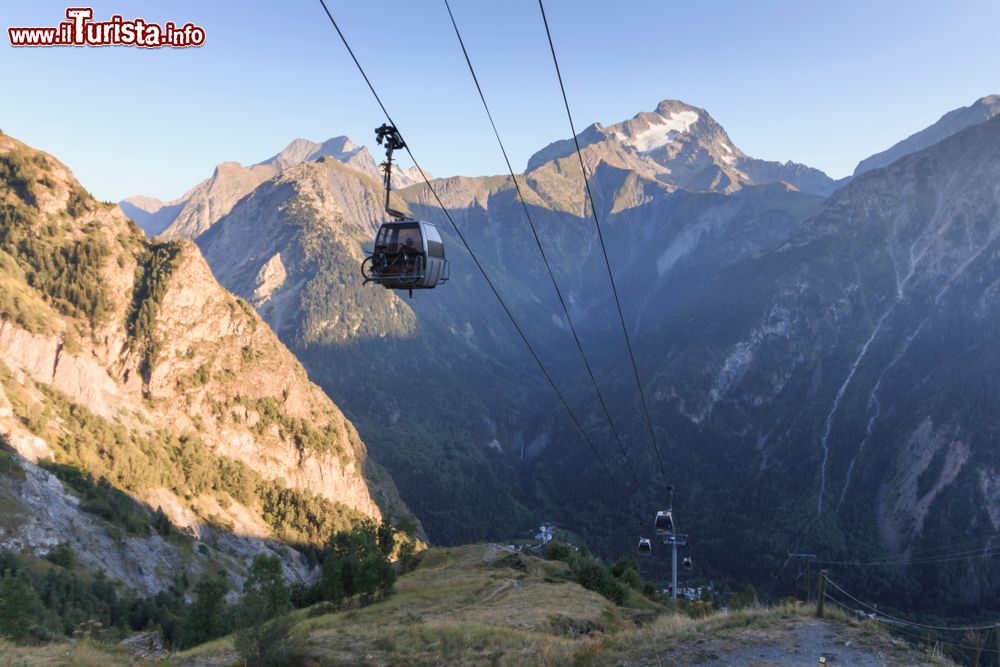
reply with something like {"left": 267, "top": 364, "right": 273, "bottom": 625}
{"left": 361, "top": 218, "right": 449, "bottom": 296}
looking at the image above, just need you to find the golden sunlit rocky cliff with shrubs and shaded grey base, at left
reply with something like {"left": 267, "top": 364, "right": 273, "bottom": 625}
{"left": 0, "top": 136, "right": 416, "bottom": 592}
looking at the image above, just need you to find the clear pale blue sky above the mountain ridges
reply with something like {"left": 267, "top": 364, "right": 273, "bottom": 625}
{"left": 0, "top": 0, "right": 1000, "bottom": 200}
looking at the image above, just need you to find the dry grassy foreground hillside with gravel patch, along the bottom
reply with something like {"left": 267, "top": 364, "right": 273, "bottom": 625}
{"left": 0, "top": 545, "right": 953, "bottom": 667}
